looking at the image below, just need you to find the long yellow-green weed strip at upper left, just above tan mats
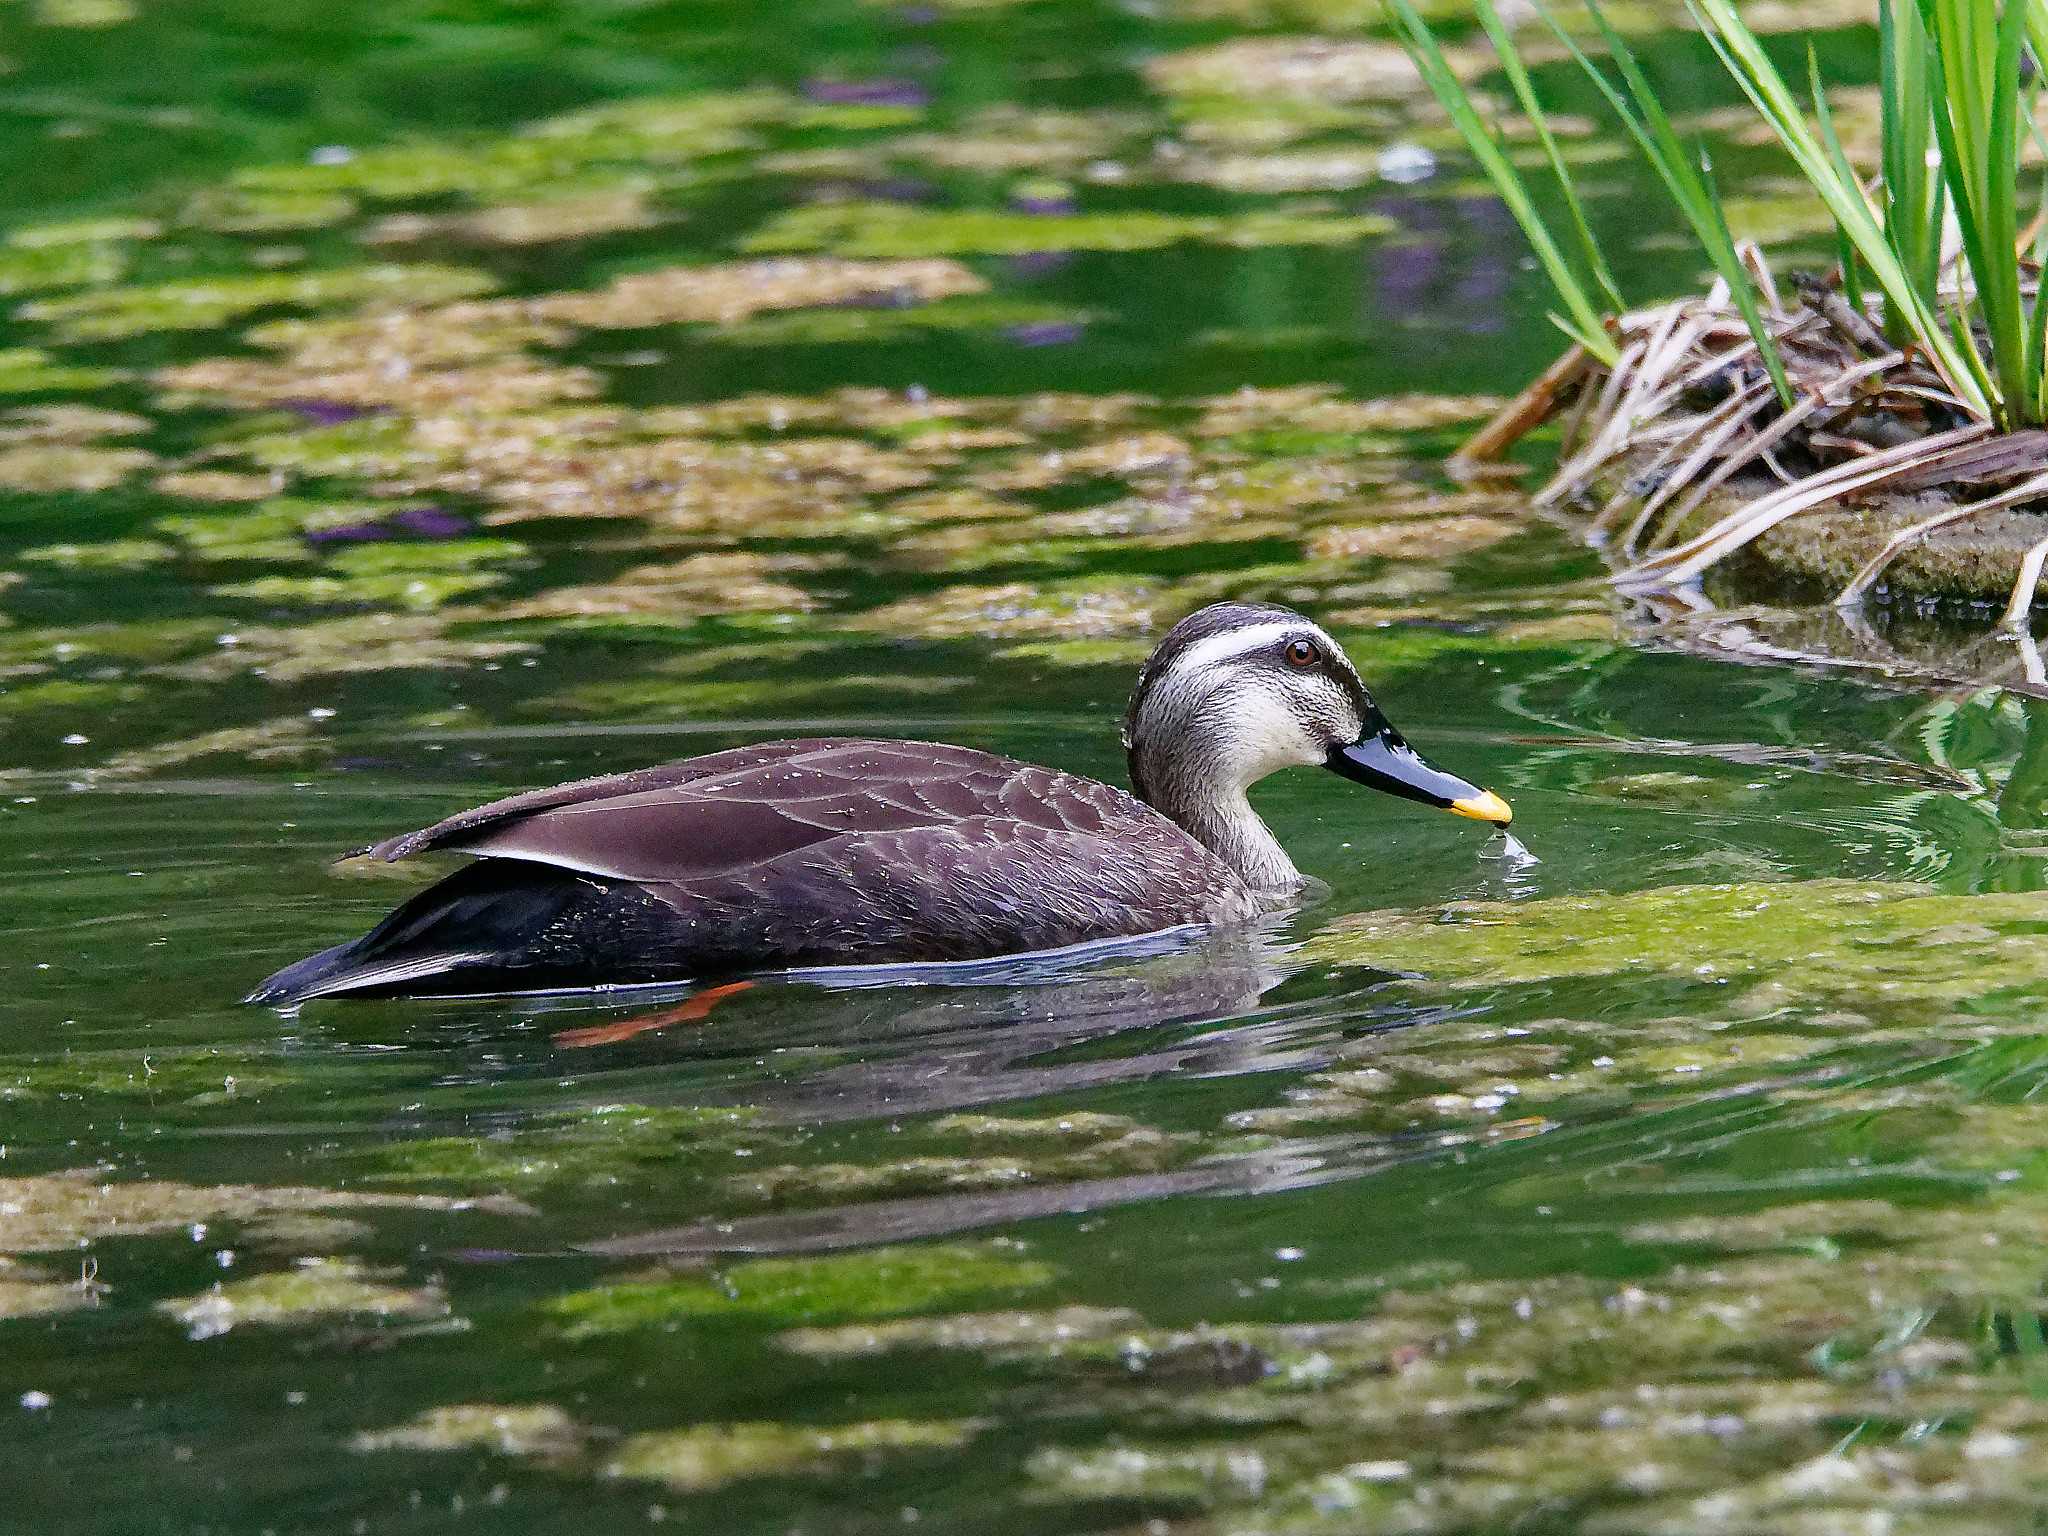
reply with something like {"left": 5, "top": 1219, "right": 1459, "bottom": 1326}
{"left": 20, "top": 264, "right": 494, "bottom": 340}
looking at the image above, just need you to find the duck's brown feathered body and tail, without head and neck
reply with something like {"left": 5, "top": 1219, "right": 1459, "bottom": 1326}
{"left": 256, "top": 737, "right": 1255, "bottom": 1001}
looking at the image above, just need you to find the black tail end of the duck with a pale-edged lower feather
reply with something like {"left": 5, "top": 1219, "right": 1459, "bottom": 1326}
{"left": 244, "top": 858, "right": 588, "bottom": 1008}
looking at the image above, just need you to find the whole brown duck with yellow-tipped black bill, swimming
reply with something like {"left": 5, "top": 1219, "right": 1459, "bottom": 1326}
{"left": 246, "top": 602, "right": 1513, "bottom": 1008}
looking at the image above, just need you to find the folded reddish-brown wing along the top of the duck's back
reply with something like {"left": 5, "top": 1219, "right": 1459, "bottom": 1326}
{"left": 369, "top": 737, "right": 1165, "bottom": 885}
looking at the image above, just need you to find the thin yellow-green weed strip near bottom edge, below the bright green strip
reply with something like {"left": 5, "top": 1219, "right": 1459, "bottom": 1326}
{"left": 604, "top": 1419, "right": 977, "bottom": 1493}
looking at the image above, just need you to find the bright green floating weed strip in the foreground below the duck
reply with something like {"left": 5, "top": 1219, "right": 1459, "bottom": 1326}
{"left": 547, "top": 1243, "right": 1055, "bottom": 1337}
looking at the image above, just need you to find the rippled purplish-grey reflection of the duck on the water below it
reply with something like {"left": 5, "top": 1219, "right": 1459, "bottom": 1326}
{"left": 471, "top": 920, "right": 1499, "bottom": 1257}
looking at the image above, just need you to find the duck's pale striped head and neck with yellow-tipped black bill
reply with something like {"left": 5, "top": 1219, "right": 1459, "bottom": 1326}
{"left": 1124, "top": 602, "right": 1513, "bottom": 887}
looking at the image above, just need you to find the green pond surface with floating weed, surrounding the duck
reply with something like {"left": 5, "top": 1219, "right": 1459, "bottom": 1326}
{"left": 12, "top": 0, "right": 2048, "bottom": 1536}
